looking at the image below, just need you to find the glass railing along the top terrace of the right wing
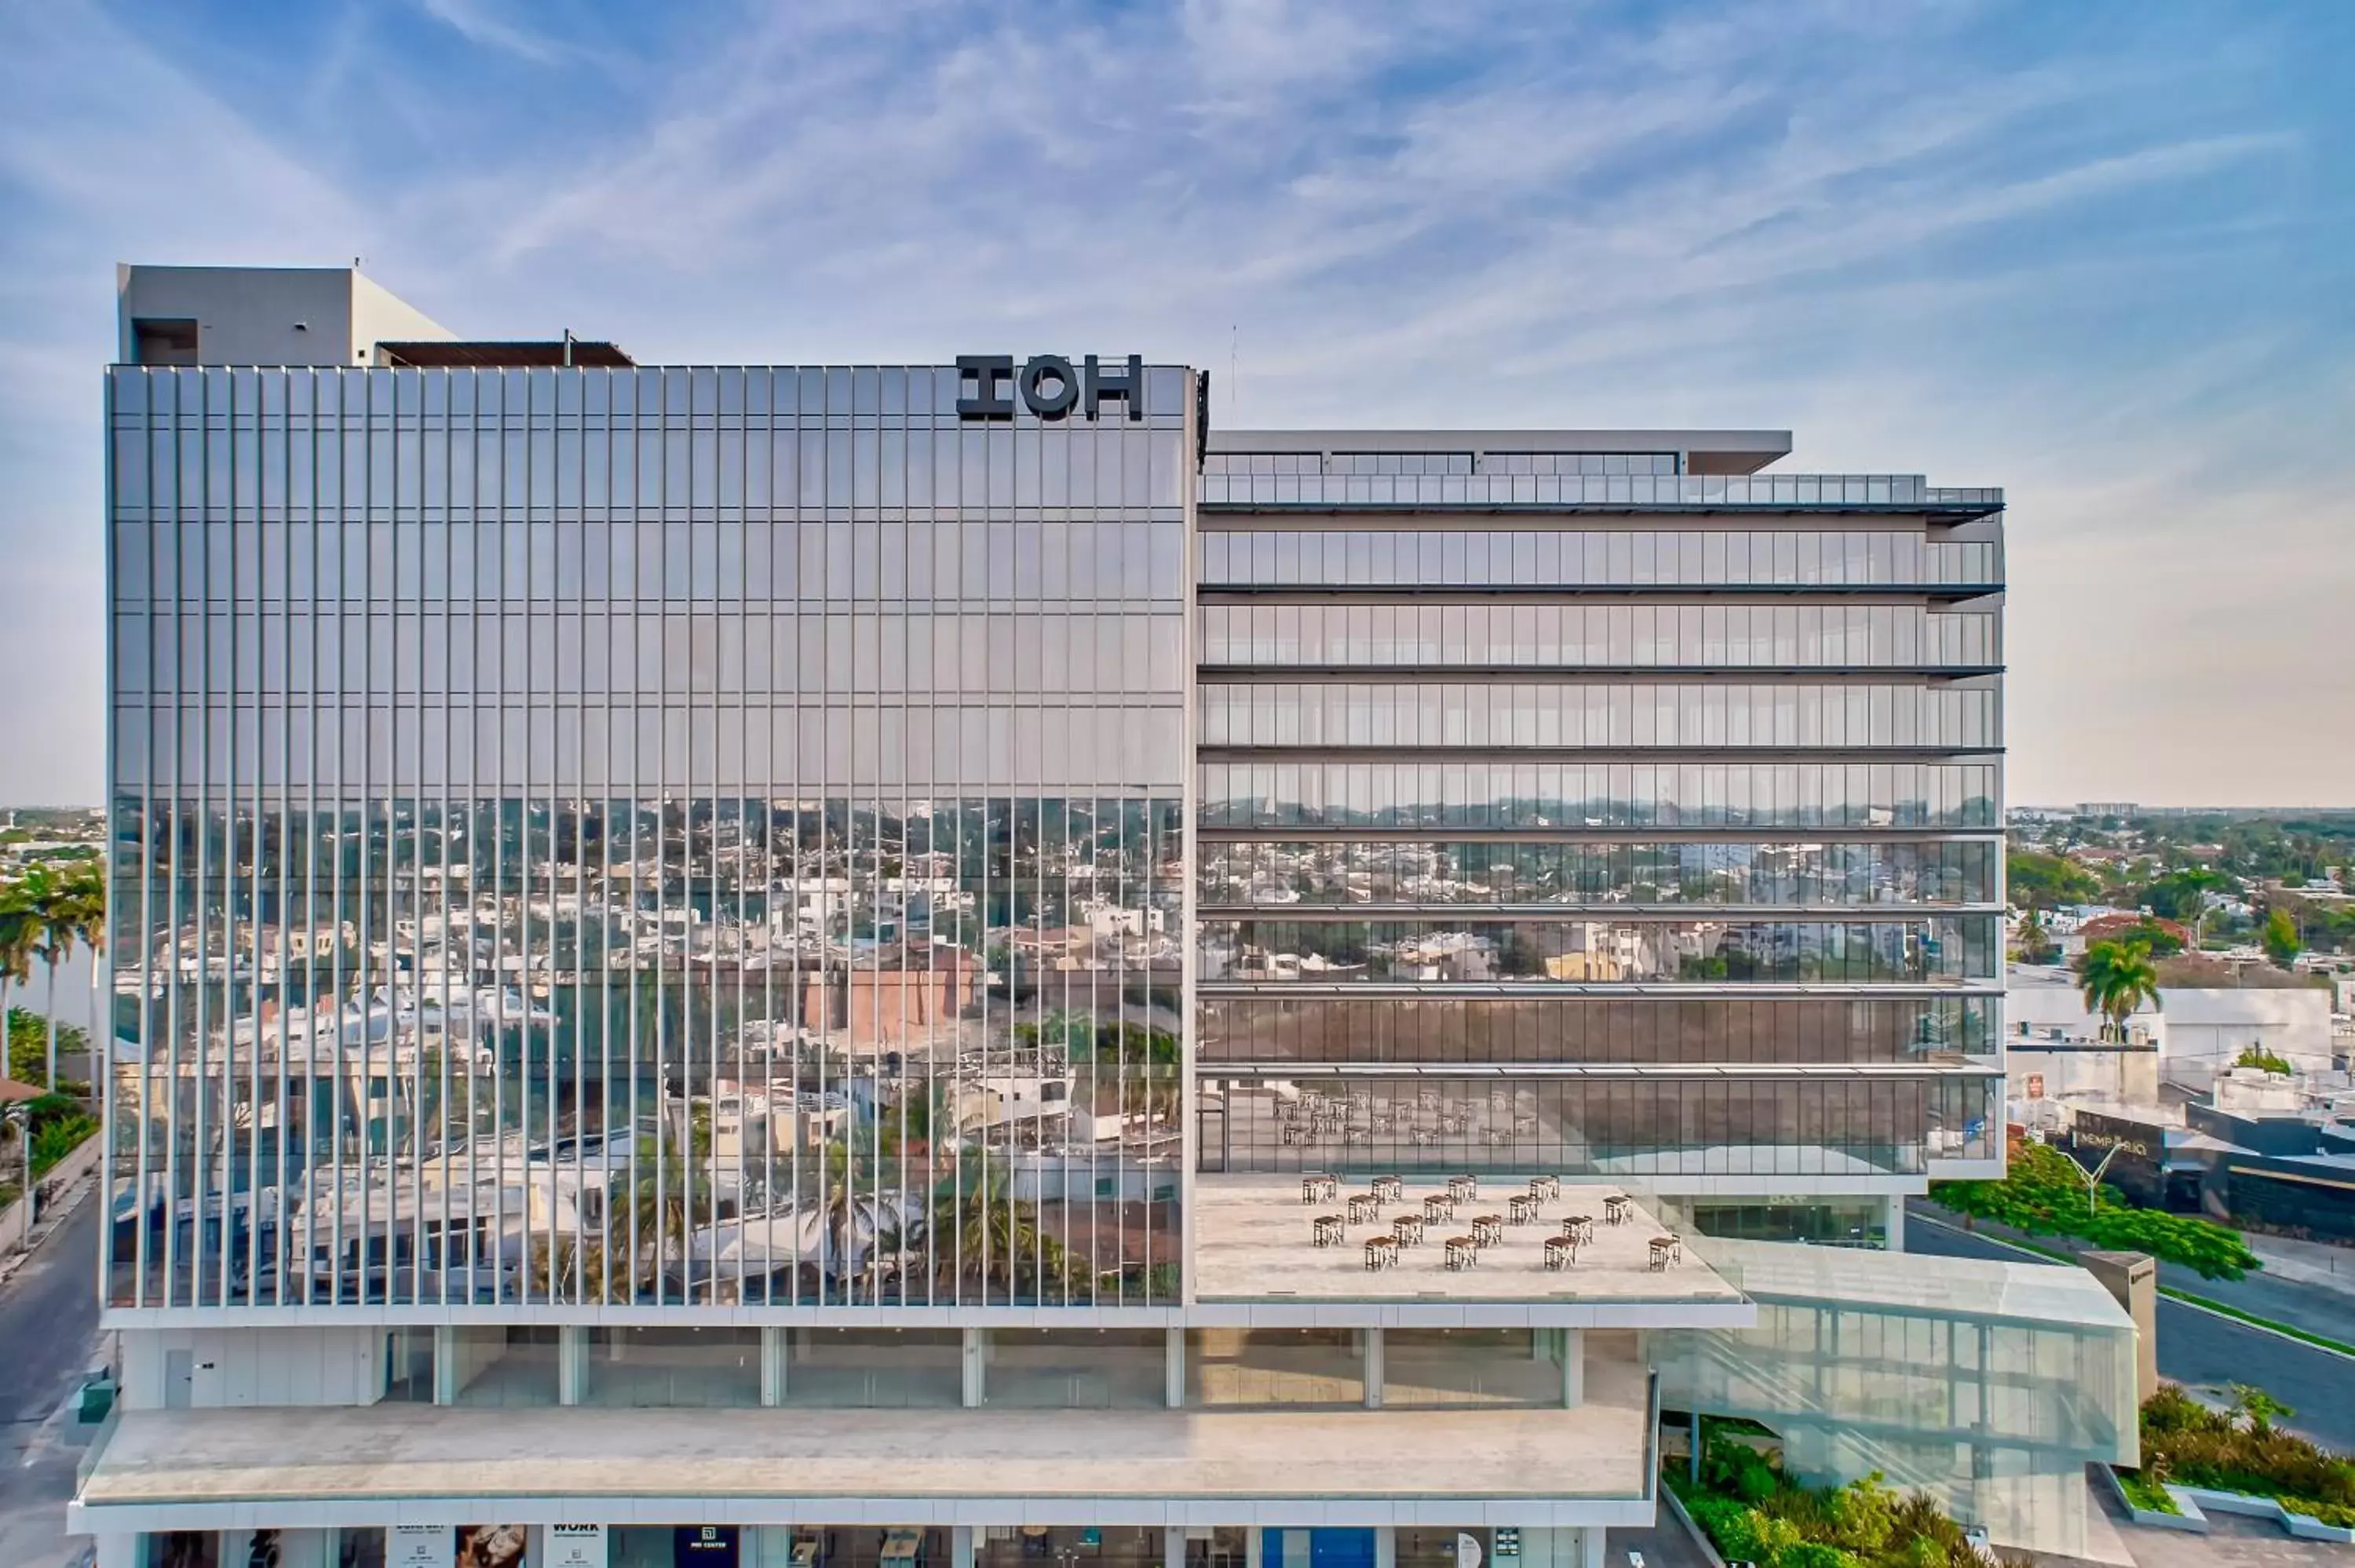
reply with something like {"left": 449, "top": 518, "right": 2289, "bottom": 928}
{"left": 1201, "top": 473, "right": 2004, "bottom": 511}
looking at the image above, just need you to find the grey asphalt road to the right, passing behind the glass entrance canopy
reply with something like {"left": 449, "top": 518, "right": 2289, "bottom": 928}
{"left": 1905, "top": 1208, "right": 2355, "bottom": 1453}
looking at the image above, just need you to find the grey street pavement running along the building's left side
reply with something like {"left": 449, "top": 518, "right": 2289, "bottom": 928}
{"left": 0, "top": 1189, "right": 101, "bottom": 1568}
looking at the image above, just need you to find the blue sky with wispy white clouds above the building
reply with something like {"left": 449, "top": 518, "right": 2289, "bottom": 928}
{"left": 0, "top": 0, "right": 2355, "bottom": 803}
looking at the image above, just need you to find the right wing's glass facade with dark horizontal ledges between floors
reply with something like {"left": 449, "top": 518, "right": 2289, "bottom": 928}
{"left": 1194, "top": 433, "right": 2002, "bottom": 1177}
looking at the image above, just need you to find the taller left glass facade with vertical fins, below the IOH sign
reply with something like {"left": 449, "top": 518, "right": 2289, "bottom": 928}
{"left": 106, "top": 367, "right": 1196, "bottom": 1307}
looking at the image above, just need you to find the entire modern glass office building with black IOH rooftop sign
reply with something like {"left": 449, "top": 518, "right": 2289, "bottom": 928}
{"left": 73, "top": 268, "right": 2131, "bottom": 1568}
